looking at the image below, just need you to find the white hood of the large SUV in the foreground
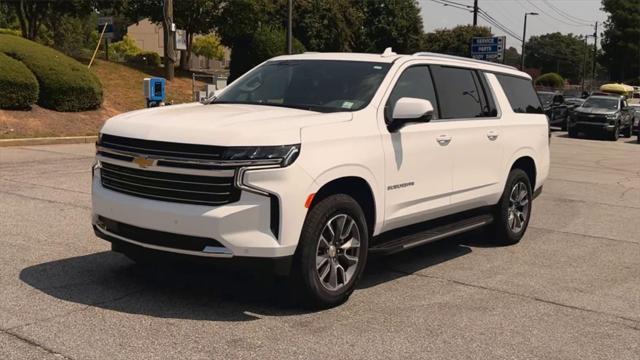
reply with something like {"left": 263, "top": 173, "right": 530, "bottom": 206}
{"left": 101, "top": 103, "right": 351, "bottom": 146}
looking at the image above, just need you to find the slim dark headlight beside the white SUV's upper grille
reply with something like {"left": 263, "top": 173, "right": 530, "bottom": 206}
{"left": 221, "top": 144, "right": 300, "bottom": 167}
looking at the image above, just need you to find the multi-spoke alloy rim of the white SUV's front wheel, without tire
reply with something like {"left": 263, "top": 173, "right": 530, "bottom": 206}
{"left": 316, "top": 214, "right": 360, "bottom": 291}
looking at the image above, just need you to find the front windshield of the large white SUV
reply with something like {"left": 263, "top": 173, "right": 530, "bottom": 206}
{"left": 211, "top": 60, "right": 391, "bottom": 112}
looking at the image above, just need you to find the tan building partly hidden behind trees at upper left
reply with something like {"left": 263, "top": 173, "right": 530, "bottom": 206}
{"left": 127, "top": 19, "right": 231, "bottom": 74}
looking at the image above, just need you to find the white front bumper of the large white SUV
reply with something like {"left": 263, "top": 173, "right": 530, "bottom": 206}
{"left": 92, "top": 163, "right": 314, "bottom": 258}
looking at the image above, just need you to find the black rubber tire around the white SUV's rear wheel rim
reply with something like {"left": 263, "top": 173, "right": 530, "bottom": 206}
{"left": 487, "top": 169, "right": 533, "bottom": 245}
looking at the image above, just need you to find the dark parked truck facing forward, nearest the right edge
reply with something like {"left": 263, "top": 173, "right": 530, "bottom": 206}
{"left": 568, "top": 95, "right": 633, "bottom": 141}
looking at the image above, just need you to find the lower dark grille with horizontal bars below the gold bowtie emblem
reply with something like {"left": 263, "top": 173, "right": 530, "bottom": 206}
{"left": 100, "top": 162, "right": 240, "bottom": 206}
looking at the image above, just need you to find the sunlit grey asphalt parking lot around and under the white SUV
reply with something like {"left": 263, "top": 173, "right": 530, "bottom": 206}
{"left": 0, "top": 132, "right": 640, "bottom": 360}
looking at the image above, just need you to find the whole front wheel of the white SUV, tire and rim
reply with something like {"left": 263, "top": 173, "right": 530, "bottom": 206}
{"left": 293, "top": 194, "right": 369, "bottom": 308}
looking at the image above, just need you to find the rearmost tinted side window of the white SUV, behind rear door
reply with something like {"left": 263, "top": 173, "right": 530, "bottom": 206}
{"left": 496, "top": 74, "right": 544, "bottom": 114}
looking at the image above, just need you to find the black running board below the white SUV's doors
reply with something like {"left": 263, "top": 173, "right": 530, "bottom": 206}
{"left": 369, "top": 214, "right": 493, "bottom": 255}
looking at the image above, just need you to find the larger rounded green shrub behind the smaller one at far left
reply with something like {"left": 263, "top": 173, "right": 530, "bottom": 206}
{"left": 0, "top": 35, "right": 102, "bottom": 111}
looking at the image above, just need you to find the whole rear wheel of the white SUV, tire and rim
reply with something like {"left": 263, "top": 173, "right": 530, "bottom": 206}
{"left": 487, "top": 169, "right": 533, "bottom": 245}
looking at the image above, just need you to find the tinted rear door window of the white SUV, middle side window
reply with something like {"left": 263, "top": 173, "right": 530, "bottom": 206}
{"left": 432, "top": 66, "right": 487, "bottom": 119}
